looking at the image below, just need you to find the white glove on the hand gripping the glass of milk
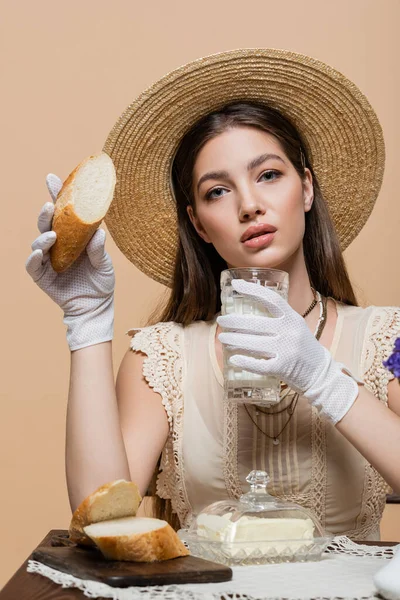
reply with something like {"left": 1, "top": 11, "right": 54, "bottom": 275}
{"left": 217, "top": 279, "right": 362, "bottom": 424}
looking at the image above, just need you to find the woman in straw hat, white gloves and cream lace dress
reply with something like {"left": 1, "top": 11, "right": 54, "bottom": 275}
{"left": 27, "top": 50, "right": 400, "bottom": 539}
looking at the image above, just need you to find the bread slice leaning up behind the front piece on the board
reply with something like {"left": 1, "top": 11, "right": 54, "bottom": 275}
{"left": 69, "top": 479, "right": 142, "bottom": 546}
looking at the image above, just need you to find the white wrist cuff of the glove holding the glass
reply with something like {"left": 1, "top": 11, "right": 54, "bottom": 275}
{"left": 304, "top": 355, "right": 364, "bottom": 425}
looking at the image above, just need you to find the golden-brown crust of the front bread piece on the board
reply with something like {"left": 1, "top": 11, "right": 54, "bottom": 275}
{"left": 85, "top": 523, "right": 190, "bottom": 562}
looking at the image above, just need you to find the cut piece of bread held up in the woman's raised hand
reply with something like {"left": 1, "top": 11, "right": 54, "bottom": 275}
{"left": 50, "top": 152, "right": 117, "bottom": 273}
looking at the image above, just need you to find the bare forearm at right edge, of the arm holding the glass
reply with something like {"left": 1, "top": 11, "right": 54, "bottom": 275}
{"left": 336, "top": 380, "right": 400, "bottom": 494}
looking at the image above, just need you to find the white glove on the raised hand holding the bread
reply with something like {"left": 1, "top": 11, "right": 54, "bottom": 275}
{"left": 25, "top": 173, "right": 115, "bottom": 350}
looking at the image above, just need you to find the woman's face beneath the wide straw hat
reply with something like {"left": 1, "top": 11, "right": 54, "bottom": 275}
{"left": 188, "top": 127, "right": 313, "bottom": 268}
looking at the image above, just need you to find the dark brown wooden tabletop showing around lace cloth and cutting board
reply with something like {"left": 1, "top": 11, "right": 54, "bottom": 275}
{"left": 0, "top": 529, "right": 398, "bottom": 600}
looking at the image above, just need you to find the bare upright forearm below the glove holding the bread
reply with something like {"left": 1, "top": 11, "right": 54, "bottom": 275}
{"left": 65, "top": 342, "right": 130, "bottom": 511}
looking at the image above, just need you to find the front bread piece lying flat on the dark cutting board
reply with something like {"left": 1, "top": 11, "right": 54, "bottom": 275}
{"left": 84, "top": 517, "right": 189, "bottom": 562}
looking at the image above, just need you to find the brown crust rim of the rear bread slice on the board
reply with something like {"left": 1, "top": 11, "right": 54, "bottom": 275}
{"left": 68, "top": 479, "right": 142, "bottom": 546}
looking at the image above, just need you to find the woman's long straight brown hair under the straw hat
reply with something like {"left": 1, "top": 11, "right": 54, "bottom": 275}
{"left": 143, "top": 102, "right": 358, "bottom": 526}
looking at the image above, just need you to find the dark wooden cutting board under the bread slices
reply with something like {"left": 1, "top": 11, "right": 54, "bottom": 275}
{"left": 31, "top": 546, "right": 232, "bottom": 587}
